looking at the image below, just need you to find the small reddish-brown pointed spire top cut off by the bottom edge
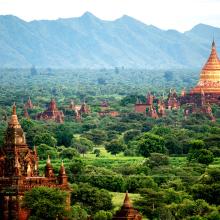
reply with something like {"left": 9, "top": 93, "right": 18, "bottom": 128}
{"left": 112, "top": 192, "right": 142, "bottom": 220}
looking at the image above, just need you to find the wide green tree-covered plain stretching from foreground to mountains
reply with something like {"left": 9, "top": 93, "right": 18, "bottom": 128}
{"left": 0, "top": 67, "right": 220, "bottom": 220}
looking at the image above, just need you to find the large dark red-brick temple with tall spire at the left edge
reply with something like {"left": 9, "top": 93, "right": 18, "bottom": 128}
{"left": 0, "top": 105, "right": 70, "bottom": 220}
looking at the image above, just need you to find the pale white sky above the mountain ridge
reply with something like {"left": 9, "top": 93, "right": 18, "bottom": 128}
{"left": 0, "top": 0, "right": 220, "bottom": 31}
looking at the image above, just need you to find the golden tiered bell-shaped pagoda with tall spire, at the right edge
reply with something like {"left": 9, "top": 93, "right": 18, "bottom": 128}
{"left": 190, "top": 40, "right": 220, "bottom": 95}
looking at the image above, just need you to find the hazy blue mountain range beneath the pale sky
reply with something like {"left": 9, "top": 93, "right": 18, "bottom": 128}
{"left": 0, "top": 12, "right": 220, "bottom": 68}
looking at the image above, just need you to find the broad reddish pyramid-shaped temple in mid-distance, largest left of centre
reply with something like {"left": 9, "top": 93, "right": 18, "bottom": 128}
{"left": 36, "top": 99, "right": 64, "bottom": 123}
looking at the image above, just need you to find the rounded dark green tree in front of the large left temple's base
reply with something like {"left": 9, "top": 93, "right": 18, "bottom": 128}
{"left": 23, "top": 187, "right": 68, "bottom": 220}
